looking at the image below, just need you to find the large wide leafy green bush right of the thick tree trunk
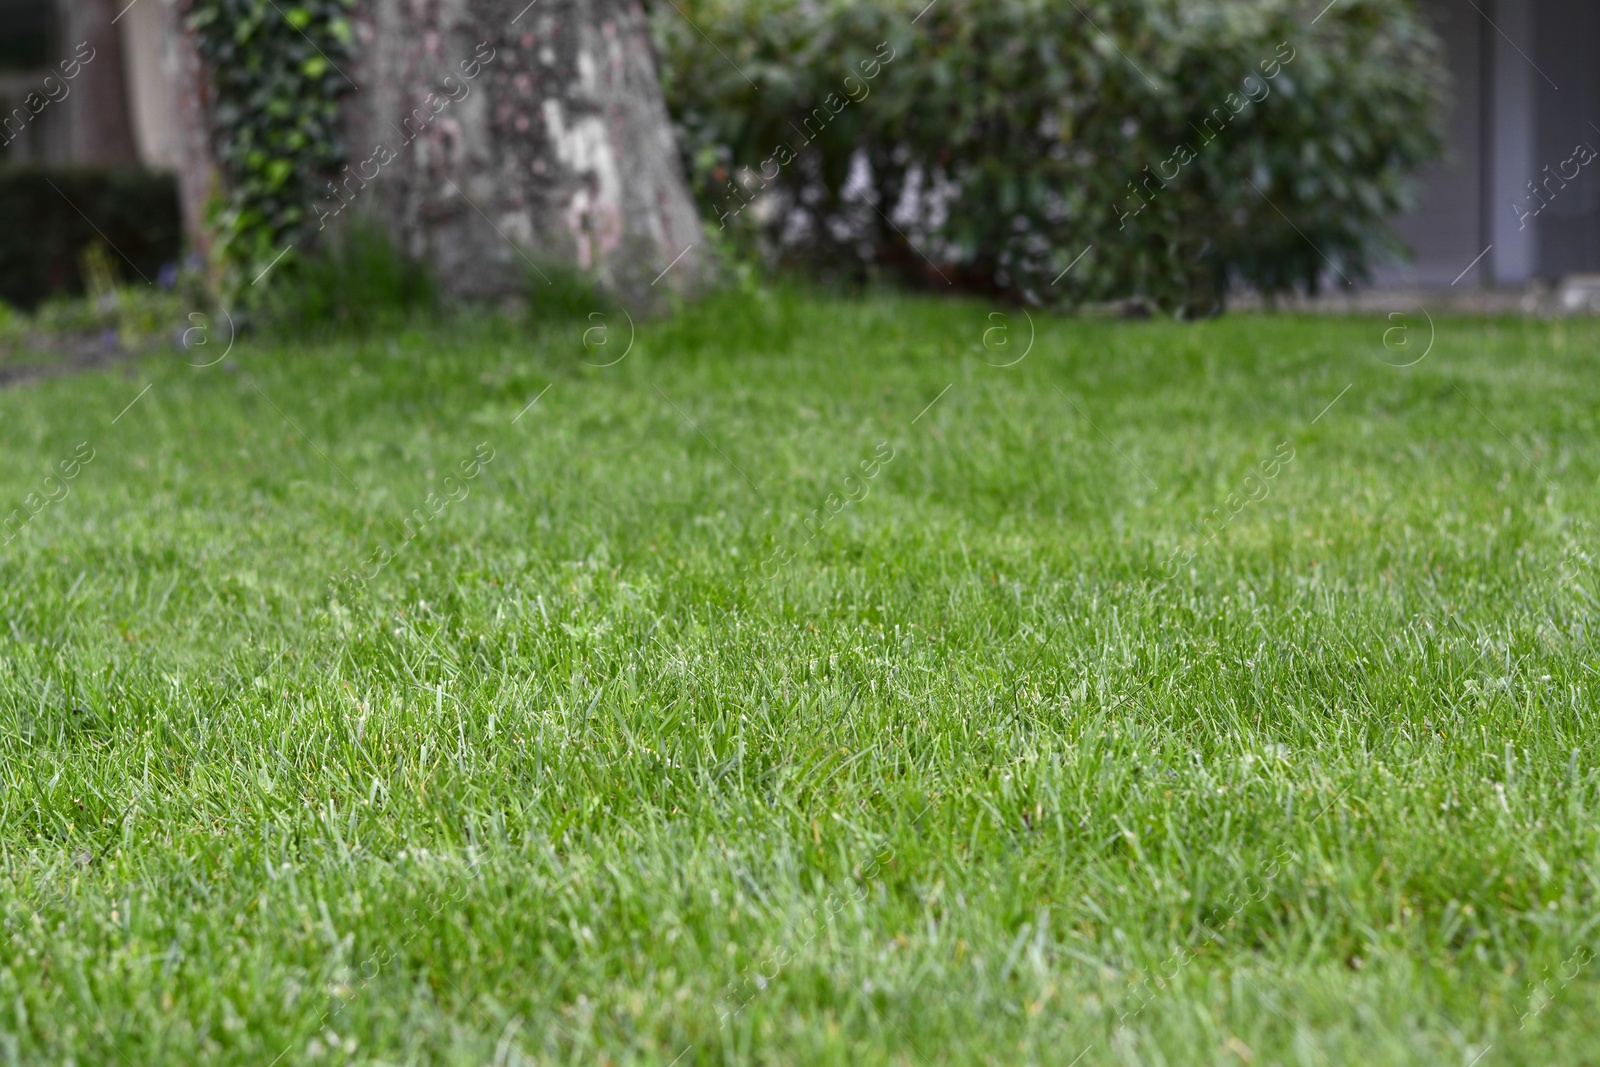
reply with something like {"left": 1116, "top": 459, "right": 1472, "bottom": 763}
{"left": 656, "top": 0, "right": 1445, "bottom": 312}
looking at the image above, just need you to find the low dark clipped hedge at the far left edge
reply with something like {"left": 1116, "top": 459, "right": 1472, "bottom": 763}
{"left": 0, "top": 166, "right": 182, "bottom": 309}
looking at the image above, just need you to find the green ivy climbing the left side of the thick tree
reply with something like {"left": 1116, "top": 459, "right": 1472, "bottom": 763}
{"left": 189, "top": 0, "right": 354, "bottom": 283}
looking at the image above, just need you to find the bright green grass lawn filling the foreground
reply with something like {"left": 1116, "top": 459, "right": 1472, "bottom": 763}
{"left": 0, "top": 291, "right": 1600, "bottom": 1067}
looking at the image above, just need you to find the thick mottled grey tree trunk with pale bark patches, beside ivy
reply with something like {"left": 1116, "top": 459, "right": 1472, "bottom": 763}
{"left": 347, "top": 0, "right": 707, "bottom": 299}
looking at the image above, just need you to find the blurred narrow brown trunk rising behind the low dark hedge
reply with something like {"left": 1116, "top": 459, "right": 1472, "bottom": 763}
{"left": 61, "top": 0, "right": 139, "bottom": 163}
